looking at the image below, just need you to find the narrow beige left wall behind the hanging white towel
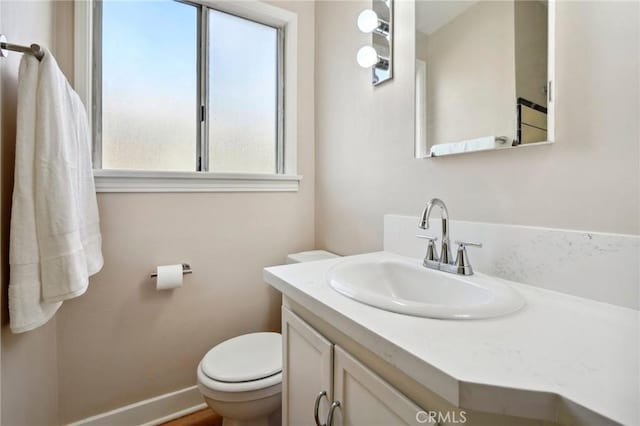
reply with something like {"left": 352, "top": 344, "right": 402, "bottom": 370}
{"left": 0, "top": 1, "right": 58, "bottom": 426}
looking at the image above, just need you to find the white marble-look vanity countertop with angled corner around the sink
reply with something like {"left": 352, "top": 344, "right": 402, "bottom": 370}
{"left": 264, "top": 252, "right": 640, "bottom": 425}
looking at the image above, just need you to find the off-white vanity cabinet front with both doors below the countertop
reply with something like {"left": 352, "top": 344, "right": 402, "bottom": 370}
{"left": 282, "top": 307, "right": 429, "bottom": 426}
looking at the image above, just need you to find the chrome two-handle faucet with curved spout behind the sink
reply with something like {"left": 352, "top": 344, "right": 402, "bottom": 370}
{"left": 416, "top": 198, "right": 482, "bottom": 275}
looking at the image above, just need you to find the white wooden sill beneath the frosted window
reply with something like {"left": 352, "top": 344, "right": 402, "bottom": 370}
{"left": 93, "top": 170, "right": 302, "bottom": 192}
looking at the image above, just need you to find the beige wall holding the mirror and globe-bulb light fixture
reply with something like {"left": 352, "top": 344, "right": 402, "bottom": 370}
{"left": 316, "top": 1, "right": 640, "bottom": 254}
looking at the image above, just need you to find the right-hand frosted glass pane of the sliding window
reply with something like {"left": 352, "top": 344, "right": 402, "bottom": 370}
{"left": 209, "top": 10, "right": 278, "bottom": 173}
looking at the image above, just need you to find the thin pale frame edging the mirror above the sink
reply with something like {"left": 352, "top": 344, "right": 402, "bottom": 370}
{"left": 411, "top": 0, "right": 558, "bottom": 159}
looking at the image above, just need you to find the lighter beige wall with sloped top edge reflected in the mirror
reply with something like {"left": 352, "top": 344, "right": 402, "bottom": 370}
{"left": 416, "top": 1, "right": 516, "bottom": 146}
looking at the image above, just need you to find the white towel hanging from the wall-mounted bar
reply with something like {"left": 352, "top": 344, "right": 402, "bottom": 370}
{"left": 9, "top": 50, "right": 103, "bottom": 333}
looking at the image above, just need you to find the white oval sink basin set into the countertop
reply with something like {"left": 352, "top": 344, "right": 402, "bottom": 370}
{"left": 327, "top": 258, "right": 524, "bottom": 319}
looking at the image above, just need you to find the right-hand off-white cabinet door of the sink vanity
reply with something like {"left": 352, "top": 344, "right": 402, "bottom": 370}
{"left": 327, "top": 345, "right": 431, "bottom": 426}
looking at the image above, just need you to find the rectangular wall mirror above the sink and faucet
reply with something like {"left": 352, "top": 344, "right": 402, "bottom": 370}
{"left": 415, "top": 0, "right": 553, "bottom": 158}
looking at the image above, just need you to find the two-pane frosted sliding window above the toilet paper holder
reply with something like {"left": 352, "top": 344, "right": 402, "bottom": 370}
{"left": 89, "top": 0, "right": 299, "bottom": 189}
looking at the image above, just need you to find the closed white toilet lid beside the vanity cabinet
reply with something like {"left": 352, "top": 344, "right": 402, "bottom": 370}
{"left": 202, "top": 333, "right": 282, "bottom": 383}
